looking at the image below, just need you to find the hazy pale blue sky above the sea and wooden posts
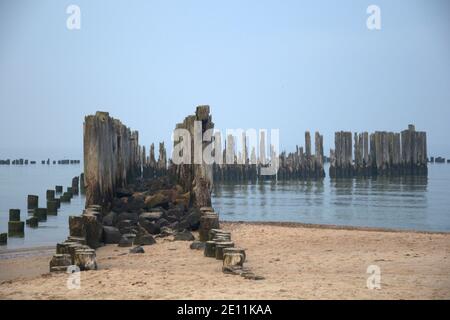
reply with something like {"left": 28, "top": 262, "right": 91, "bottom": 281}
{"left": 0, "top": 0, "right": 450, "bottom": 158}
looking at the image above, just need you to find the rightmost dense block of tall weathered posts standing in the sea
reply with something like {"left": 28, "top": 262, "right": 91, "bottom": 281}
{"left": 330, "top": 125, "right": 428, "bottom": 178}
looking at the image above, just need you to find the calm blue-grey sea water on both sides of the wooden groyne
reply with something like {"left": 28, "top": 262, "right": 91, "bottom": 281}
{"left": 0, "top": 164, "right": 450, "bottom": 250}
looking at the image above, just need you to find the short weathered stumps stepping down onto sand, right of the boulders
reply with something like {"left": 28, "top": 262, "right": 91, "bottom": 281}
{"left": 199, "top": 207, "right": 263, "bottom": 280}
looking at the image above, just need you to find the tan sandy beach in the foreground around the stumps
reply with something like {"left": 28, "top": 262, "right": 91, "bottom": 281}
{"left": 0, "top": 223, "right": 450, "bottom": 299}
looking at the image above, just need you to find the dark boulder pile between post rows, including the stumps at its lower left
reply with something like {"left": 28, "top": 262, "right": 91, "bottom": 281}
{"left": 50, "top": 177, "right": 202, "bottom": 271}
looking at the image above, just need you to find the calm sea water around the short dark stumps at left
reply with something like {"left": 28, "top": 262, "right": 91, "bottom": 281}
{"left": 0, "top": 164, "right": 84, "bottom": 250}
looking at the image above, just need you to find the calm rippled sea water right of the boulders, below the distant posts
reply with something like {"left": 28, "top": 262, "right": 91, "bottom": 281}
{"left": 213, "top": 164, "right": 450, "bottom": 231}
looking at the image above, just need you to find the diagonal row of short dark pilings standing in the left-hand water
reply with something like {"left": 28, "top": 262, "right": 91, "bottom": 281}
{"left": 0, "top": 173, "right": 85, "bottom": 245}
